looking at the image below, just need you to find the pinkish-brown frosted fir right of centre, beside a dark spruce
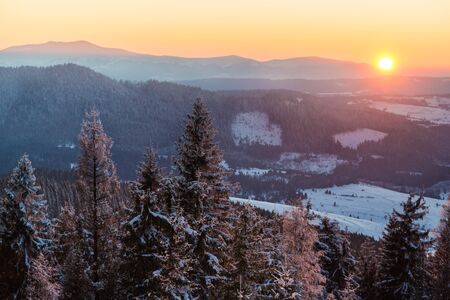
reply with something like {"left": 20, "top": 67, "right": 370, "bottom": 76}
{"left": 282, "top": 207, "right": 325, "bottom": 299}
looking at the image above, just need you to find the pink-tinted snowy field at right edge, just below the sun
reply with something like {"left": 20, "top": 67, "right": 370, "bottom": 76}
{"left": 370, "top": 101, "right": 450, "bottom": 125}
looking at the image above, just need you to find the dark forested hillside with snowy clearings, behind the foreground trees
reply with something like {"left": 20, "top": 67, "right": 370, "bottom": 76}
{"left": 0, "top": 64, "right": 450, "bottom": 193}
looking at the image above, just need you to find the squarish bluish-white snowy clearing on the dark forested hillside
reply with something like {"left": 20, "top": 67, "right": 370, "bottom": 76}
{"left": 231, "top": 112, "right": 281, "bottom": 146}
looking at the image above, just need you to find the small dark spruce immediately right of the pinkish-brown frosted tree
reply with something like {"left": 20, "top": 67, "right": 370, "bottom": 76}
{"left": 317, "top": 217, "right": 357, "bottom": 299}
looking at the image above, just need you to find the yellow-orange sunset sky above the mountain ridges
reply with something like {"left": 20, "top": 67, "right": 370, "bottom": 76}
{"left": 0, "top": 0, "right": 450, "bottom": 69}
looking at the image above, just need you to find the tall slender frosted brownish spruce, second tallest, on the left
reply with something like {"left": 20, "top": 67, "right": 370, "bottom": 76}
{"left": 77, "top": 111, "right": 119, "bottom": 299}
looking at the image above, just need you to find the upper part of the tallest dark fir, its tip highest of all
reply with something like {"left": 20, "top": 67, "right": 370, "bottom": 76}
{"left": 175, "top": 99, "right": 230, "bottom": 218}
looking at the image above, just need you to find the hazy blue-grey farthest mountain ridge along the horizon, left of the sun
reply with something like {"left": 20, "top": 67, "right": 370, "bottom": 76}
{"left": 0, "top": 41, "right": 375, "bottom": 81}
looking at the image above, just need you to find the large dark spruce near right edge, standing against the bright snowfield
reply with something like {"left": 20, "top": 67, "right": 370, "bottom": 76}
{"left": 376, "top": 196, "right": 430, "bottom": 300}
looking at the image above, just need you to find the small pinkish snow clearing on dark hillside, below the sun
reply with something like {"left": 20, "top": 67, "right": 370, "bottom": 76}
{"left": 333, "top": 128, "right": 387, "bottom": 150}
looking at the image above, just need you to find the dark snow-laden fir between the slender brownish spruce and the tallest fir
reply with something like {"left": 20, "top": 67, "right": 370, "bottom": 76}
{"left": 118, "top": 150, "right": 174, "bottom": 299}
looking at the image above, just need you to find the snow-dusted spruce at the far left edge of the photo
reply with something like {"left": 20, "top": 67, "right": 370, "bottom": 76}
{"left": 0, "top": 155, "right": 43, "bottom": 299}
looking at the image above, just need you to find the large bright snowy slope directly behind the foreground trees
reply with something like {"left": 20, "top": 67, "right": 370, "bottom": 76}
{"left": 231, "top": 183, "right": 445, "bottom": 239}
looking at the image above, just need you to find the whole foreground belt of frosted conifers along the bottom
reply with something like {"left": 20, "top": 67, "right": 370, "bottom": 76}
{"left": 0, "top": 99, "right": 450, "bottom": 300}
